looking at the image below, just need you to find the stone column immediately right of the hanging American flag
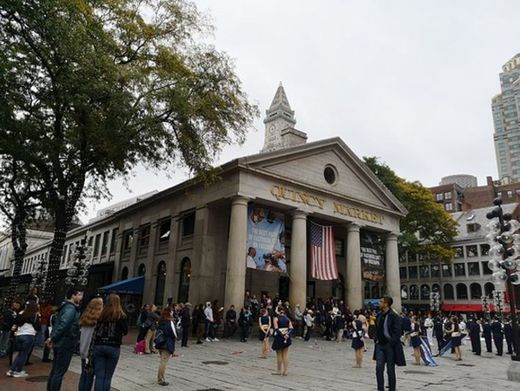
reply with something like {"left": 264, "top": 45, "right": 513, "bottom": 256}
{"left": 345, "top": 223, "right": 363, "bottom": 311}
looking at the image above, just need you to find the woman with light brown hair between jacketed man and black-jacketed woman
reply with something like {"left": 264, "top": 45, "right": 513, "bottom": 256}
{"left": 78, "top": 297, "right": 103, "bottom": 391}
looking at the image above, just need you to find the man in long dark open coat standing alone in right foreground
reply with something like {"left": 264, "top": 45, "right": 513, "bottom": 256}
{"left": 374, "top": 296, "right": 406, "bottom": 391}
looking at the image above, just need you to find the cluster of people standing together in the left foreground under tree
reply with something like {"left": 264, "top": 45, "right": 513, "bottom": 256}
{"left": 2, "top": 288, "right": 128, "bottom": 391}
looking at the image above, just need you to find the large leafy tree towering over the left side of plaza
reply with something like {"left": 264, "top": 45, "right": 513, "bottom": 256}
{"left": 0, "top": 0, "right": 257, "bottom": 302}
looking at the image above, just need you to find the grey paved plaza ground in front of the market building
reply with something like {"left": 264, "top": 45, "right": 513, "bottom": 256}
{"left": 0, "top": 339, "right": 520, "bottom": 391}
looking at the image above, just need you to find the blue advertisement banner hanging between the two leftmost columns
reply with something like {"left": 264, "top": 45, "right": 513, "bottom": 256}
{"left": 246, "top": 204, "right": 287, "bottom": 273}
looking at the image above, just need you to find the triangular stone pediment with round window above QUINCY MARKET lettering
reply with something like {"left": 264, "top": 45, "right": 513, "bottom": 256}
{"left": 239, "top": 138, "right": 406, "bottom": 215}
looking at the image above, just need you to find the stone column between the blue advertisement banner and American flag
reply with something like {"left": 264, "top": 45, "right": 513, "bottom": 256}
{"left": 289, "top": 210, "right": 307, "bottom": 308}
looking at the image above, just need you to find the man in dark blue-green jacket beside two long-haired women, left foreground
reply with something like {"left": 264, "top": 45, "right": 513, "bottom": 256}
{"left": 47, "top": 288, "right": 83, "bottom": 391}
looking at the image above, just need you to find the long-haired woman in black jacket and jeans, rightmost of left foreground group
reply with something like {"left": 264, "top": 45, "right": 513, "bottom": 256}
{"left": 93, "top": 293, "right": 128, "bottom": 391}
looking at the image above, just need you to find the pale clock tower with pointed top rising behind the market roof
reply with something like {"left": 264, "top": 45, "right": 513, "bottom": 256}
{"left": 261, "top": 83, "right": 307, "bottom": 152}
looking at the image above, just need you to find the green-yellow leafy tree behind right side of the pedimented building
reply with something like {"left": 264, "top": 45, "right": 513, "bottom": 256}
{"left": 363, "top": 157, "right": 458, "bottom": 263}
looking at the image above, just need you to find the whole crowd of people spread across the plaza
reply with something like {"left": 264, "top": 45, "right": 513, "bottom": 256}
{"left": 0, "top": 288, "right": 514, "bottom": 391}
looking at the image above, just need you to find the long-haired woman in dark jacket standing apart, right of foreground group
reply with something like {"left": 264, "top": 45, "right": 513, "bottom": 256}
{"left": 155, "top": 307, "right": 177, "bottom": 386}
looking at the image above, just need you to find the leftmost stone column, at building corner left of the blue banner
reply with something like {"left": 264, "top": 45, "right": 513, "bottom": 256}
{"left": 224, "top": 196, "right": 248, "bottom": 309}
